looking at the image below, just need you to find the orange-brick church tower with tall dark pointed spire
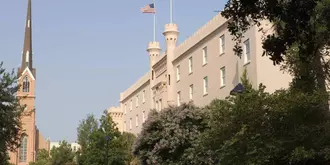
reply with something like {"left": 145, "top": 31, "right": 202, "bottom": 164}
{"left": 9, "top": 0, "right": 49, "bottom": 165}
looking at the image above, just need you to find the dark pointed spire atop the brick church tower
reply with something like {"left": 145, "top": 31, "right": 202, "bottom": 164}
{"left": 21, "top": 0, "right": 33, "bottom": 71}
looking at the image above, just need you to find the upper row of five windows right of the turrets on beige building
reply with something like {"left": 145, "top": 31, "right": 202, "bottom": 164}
{"left": 176, "top": 35, "right": 251, "bottom": 81}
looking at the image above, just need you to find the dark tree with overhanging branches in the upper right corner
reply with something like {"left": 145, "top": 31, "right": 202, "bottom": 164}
{"left": 222, "top": 0, "right": 330, "bottom": 95}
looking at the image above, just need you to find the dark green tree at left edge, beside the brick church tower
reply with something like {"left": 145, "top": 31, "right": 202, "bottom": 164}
{"left": 0, "top": 62, "right": 24, "bottom": 164}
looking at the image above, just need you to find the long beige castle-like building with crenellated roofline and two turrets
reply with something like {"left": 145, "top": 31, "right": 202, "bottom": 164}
{"left": 111, "top": 13, "right": 292, "bottom": 134}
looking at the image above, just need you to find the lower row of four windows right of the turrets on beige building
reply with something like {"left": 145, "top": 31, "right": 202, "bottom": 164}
{"left": 177, "top": 67, "right": 226, "bottom": 106}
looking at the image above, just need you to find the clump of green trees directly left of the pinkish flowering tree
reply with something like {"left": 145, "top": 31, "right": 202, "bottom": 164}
{"left": 78, "top": 111, "right": 135, "bottom": 165}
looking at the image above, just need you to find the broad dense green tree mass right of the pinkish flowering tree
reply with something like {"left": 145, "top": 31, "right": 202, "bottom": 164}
{"left": 200, "top": 72, "right": 330, "bottom": 165}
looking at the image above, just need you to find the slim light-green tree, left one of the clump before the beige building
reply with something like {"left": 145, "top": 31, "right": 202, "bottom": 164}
{"left": 77, "top": 114, "right": 98, "bottom": 164}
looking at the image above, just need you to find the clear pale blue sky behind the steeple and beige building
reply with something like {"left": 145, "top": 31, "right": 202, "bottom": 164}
{"left": 0, "top": 0, "right": 226, "bottom": 141}
